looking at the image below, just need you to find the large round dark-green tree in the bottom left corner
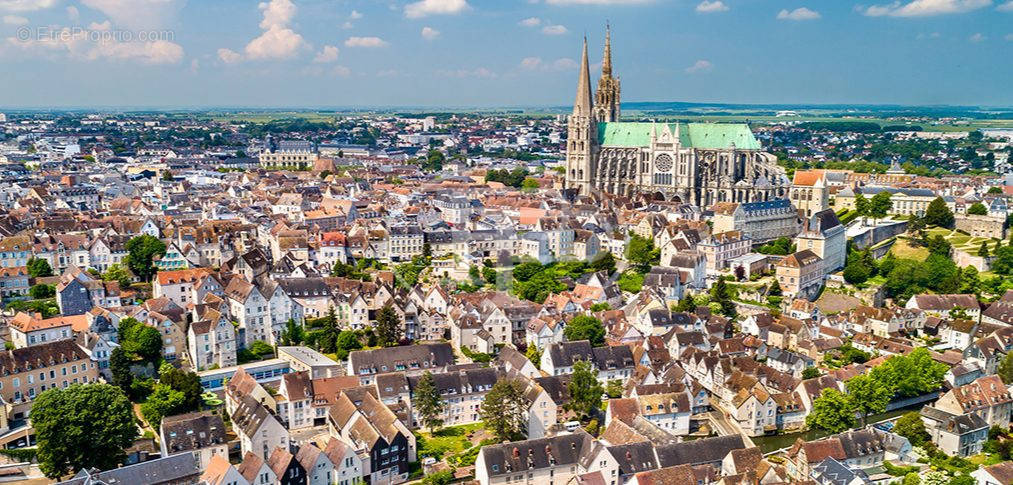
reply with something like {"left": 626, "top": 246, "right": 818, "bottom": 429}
{"left": 31, "top": 384, "right": 137, "bottom": 479}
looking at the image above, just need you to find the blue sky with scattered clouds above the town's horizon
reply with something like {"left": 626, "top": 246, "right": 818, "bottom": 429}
{"left": 0, "top": 0, "right": 1013, "bottom": 107}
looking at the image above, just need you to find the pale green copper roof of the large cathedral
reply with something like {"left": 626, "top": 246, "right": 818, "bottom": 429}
{"left": 598, "top": 122, "right": 761, "bottom": 150}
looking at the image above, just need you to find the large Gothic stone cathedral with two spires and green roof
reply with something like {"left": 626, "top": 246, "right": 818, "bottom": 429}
{"left": 565, "top": 31, "right": 790, "bottom": 207}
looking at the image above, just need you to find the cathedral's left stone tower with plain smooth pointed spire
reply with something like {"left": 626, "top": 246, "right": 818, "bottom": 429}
{"left": 566, "top": 37, "right": 598, "bottom": 195}
